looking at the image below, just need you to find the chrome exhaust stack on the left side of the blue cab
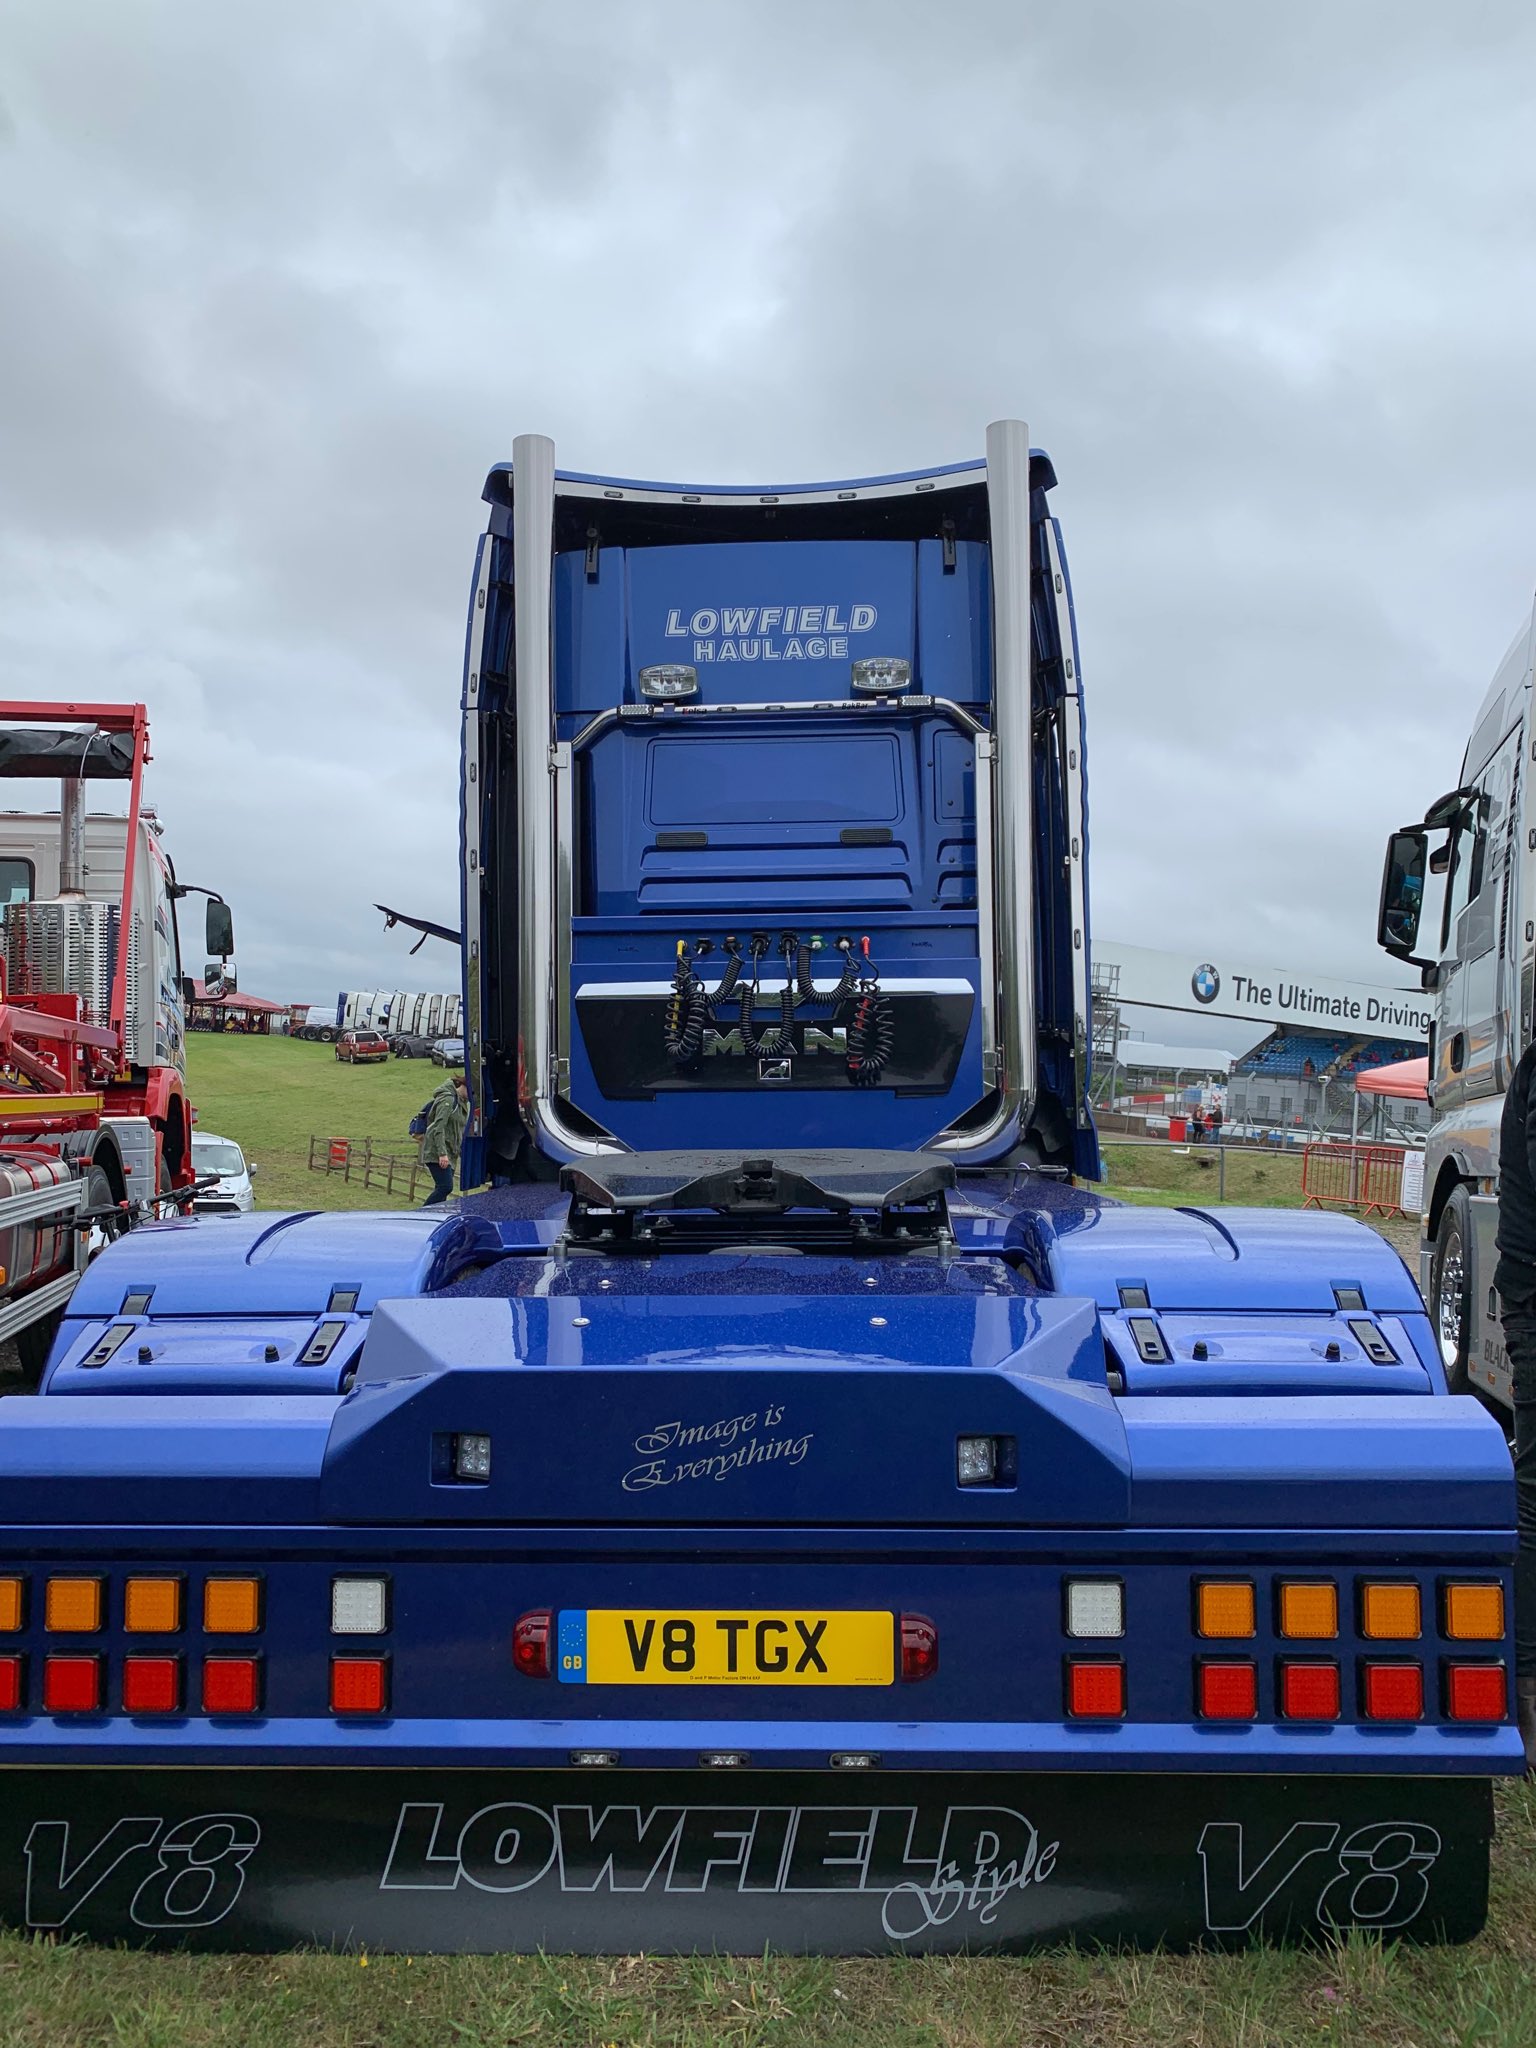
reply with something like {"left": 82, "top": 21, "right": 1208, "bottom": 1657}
{"left": 512, "top": 434, "right": 629, "bottom": 1159}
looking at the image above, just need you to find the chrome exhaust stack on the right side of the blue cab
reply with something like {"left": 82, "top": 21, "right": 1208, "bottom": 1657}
{"left": 928, "top": 420, "right": 1036, "bottom": 1163}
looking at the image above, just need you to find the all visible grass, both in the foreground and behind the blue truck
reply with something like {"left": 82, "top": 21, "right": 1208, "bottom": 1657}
{"left": 0, "top": 1038, "right": 1536, "bottom": 2048}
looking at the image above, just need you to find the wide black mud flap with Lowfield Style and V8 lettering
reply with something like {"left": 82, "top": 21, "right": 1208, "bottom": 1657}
{"left": 0, "top": 1769, "right": 1493, "bottom": 1956}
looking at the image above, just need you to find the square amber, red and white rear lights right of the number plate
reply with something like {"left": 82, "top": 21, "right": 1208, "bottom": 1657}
{"left": 1063, "top": 1575, "right": 1509, "bottom": 1722}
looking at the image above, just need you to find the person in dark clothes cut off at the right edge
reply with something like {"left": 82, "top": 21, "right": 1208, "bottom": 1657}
{"left": 1493, "top": 1040, "right": 1536, "bottom": 1772}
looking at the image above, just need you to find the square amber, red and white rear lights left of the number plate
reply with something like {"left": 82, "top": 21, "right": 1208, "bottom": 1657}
{"left": 0, "top": 1573, "right": 389, "bottom": 1716}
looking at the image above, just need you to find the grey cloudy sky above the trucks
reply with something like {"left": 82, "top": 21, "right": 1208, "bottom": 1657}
{"left": 0, "top": 0, "right": 1536, "bottom": 1034}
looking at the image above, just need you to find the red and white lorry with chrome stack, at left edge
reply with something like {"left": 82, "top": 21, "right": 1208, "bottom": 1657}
{"left": 0, "top": 702, "right": 233, "bottom": 1374}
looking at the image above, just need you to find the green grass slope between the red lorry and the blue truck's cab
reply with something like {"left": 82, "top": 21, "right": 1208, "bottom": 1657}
{"left": 186, "top": 1032, "right": 444, "bottom": 1208}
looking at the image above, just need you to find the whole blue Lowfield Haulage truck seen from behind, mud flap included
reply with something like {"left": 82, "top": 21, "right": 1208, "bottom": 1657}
{"left": 0, "top": 422, "right": 1522, "bottom": 1954}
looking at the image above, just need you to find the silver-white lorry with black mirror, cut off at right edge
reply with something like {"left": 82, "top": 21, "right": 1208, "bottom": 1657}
{"left": 1376, "top": 598, "right": 1536, "bottom": 1407}
